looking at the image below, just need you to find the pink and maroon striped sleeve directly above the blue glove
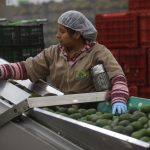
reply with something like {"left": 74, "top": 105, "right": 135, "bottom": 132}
{"left": 111, "top": 75, "right": 129, "bottom": 104}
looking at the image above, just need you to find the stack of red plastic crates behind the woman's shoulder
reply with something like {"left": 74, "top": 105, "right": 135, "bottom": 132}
{"left": 95, "top": 0, "right": 150, "bottom": 98}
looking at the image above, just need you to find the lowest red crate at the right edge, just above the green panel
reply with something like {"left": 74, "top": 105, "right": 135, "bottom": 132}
{"left": 139, "top": 86, "right": 150, "bottom": 99}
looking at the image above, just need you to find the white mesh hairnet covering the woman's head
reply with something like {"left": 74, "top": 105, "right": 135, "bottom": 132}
{"left": 58, "top": 10, "right": 97, "bottom": 40}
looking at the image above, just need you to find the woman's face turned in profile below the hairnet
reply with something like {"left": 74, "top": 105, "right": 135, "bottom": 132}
{"left": 56, "top": 24, "right": 76, "bottom": 47}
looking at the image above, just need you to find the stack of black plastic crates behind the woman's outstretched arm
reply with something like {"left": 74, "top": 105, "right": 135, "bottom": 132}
{"left": 0, "top": 21, "right": 44, "bottom": 62}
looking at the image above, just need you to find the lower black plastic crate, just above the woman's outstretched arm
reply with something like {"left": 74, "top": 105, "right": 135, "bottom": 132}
{"left": 0, "top": 47, "right": 42, "bottom": 62}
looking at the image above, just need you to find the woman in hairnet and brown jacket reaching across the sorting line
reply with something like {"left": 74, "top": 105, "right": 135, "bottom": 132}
{"left": 0, "top": 10, "right": 129, "bottom": 114}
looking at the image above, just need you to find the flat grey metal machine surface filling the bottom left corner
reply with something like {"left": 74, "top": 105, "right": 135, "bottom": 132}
{"left": 0, "top": 103, "right": 83, "bottom": 150}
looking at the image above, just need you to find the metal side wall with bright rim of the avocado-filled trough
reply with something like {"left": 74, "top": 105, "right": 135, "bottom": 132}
{"left": 30, "top": 108, "right": 150, "bottom": 150}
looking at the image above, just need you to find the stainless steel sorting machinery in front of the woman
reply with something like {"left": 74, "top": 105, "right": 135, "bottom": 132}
{"left": 0, "top": 57, "right": 150, "bottom": 150}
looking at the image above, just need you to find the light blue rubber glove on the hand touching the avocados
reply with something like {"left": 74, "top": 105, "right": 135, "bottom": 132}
{"left": 112, "top": 102, "right": 127, "bottom": 114}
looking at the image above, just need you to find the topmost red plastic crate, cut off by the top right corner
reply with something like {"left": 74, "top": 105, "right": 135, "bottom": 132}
{"left": 128, "top": 0, "right": 150, "bottom": 11}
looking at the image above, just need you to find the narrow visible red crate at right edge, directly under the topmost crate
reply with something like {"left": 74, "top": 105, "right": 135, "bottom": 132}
{"left": 139, "top": 11, "right": 150, "bottom": 48}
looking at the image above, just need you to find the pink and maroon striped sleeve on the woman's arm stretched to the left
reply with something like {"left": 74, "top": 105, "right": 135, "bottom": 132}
{"left": 0, "top": 62, "right": 28, "bottom": 80}
